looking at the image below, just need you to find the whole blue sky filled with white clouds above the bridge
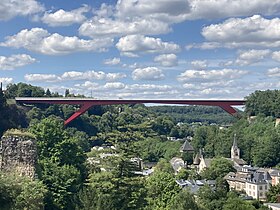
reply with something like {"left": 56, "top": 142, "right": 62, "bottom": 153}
{"left": 0, "top": 0, "right": 280, "bottom": 99}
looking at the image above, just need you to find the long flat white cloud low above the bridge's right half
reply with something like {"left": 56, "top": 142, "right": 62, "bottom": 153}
{"left": 177, "top": 69, "right": 247, "bottom": 82}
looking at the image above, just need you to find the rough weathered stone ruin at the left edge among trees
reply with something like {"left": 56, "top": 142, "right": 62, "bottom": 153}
{"left": 0, "top": 135, "right": 37, "bottom": 179}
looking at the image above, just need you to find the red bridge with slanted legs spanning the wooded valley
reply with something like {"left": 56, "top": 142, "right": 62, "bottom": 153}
{"left": 16, "top": 97, "right": 245, "bottom": 125}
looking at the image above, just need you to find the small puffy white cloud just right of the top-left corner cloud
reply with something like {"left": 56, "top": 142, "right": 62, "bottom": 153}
{"left": 42, "top": 5, "right": 90, "bottom": 27}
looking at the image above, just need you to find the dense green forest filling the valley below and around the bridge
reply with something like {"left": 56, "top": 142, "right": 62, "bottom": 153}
{"left": 0, "top": 83, "right": 280, "bottom": 210}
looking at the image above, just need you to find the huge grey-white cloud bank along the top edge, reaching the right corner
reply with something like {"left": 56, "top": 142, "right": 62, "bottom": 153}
{"left": 79, "top": 0, "right": 280, "bottom": 37}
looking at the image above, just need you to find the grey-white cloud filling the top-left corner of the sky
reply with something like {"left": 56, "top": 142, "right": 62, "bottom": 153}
{"left": 0, "top": 0, "right": 44, "bottom": 21}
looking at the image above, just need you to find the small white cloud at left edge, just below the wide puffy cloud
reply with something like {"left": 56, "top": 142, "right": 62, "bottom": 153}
{"left": 0, "top": 54, "right": 36, "bottom": 70}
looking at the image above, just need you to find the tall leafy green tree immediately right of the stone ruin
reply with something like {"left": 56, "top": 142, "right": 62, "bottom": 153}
{"left": 29, "top": 116, "right": 87, "bottom": 210}
